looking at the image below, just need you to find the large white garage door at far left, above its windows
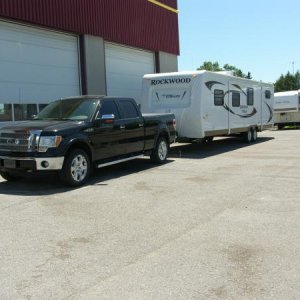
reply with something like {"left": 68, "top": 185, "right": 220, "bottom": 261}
{"left": 0, "top": 22, "right": 80, "bottom": 104}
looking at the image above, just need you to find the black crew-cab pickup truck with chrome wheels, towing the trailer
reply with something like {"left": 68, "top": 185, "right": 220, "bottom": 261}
{"left": 0, "top": 96, "right": 175, "bottom": 186}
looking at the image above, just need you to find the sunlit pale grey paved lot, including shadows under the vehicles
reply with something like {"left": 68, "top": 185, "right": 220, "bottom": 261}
{"left": 0, "top": 130, "right": 300, "bottom": 299}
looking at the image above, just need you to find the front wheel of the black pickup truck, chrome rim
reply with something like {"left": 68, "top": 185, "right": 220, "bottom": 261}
{"left": 60, "top": 149, "right": 91, "bottom": 187}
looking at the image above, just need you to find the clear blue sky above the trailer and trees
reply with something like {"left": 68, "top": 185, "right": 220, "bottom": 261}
{"left": 178, "top": 0, "right": 300, "bottom": 82}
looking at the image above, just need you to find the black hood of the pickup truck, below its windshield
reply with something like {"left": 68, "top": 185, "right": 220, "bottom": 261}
{"left": 0, "top": 120, "right": 86, "bottom": 132}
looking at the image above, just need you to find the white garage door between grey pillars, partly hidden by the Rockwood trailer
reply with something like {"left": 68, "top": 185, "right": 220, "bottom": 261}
{"left": 105, "top": 43, "right": 155, "bottom": 103}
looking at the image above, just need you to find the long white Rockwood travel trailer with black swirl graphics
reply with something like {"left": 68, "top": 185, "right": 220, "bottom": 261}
{"left": 141, "top": 71, "right": 274, "bottom": 142}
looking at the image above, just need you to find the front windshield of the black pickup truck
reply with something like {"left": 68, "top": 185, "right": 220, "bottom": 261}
{"left": 35, "top": 98, "right": 98, "bottom": 121}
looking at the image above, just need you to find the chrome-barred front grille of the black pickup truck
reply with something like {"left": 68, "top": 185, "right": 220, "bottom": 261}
{"left": 0, "top": 131, "right": 33, "bottom": 152}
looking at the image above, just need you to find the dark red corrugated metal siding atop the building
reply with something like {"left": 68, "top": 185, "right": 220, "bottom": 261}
{"left": 0, "top": 0, "right": 179, "bottom": 54}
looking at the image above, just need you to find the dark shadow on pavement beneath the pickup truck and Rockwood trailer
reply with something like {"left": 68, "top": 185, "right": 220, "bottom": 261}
{"left": 0, "top": 137, "right": 273, "bottom": 196}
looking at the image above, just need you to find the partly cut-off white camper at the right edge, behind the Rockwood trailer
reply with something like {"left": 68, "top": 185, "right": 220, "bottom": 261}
{"left": 274, "top": 90, "right": 300, "bottom": 129}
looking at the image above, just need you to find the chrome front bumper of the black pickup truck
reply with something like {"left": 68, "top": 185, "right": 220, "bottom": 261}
{"left": 0, "top": 156, "right": 64, "bottom": 172}
